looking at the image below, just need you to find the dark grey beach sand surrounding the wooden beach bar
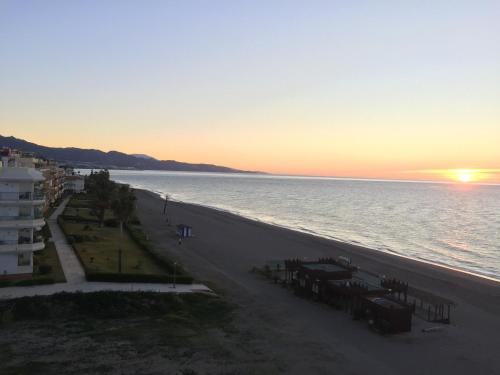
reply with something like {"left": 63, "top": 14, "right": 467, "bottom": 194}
{"left": 137, "top": 190, "right": 500, "bottom": 374}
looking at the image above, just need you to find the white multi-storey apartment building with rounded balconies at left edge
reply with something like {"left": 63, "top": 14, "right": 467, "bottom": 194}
{"left": 0, "top": 150, "right": 45, "bottom": 279}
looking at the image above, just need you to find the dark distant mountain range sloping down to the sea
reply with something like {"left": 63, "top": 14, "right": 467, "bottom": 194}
{"left": 0, "top": 135, "right": 259, "bottom": 173}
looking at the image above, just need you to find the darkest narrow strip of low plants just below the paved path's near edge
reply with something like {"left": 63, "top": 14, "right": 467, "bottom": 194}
{"left": 0, "top": 291, "right": 235, "bottom": 329}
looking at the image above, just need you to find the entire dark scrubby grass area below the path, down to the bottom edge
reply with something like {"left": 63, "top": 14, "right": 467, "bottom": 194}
{"left": 0, "top": 292, "right": 239, "bottom": 374}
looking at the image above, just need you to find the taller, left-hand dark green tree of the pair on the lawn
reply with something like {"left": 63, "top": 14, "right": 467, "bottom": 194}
{"left": 85, "top": 169, "right": 116, "bottom": 227}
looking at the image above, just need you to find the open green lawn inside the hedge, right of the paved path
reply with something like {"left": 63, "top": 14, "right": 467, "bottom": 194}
{"left": 63, "top": 221, "right": 167, "bottom": 275}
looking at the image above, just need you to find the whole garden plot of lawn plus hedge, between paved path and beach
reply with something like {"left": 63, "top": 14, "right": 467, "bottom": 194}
{"left": 59, "top": 194, "right": 192, "bottom": 283}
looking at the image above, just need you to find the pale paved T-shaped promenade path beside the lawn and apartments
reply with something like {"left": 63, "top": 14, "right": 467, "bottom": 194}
{"left": 0, "top": 198, "right": 212, "bottom": 299}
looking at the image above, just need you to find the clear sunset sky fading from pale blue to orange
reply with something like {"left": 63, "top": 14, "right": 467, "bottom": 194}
{"left": 0, "top": 0, "right": 500, "bottom": 182}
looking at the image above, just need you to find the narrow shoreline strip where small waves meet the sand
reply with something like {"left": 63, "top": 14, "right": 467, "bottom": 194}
{"left": 140, "top": 188, "right": 500, "bottom": 287}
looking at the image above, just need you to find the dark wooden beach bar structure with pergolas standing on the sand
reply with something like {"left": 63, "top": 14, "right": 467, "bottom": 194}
{"left": 263, "top": 257, "right": 453, "bottom": 334}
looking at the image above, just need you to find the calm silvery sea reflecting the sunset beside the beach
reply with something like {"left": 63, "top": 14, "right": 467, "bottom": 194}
{"left": 84, "top": 170, "right": 500, "bottom": 280}
